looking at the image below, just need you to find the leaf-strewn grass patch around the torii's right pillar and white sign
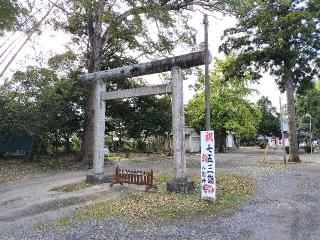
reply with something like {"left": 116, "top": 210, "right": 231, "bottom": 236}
{"left": 71, "top": 172, "right": 254, "bottom": 225}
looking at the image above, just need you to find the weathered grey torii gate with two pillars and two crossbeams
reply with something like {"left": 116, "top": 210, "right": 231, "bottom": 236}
{"left": 78, "top": 51, "right": 210, "bottom": 188}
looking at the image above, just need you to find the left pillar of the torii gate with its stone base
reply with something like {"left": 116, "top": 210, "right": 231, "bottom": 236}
{"left": 87, "top": 81, "right": 106, "bottom": 184}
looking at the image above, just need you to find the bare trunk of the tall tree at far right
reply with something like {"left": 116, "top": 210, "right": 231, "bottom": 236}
{"left": 284, "top": 66, "right": 300, "bottom": 162}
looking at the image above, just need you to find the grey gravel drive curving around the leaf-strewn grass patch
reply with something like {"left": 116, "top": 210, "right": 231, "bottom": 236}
{"left": 0, "top": 148, "right": 320, "bottom": 240}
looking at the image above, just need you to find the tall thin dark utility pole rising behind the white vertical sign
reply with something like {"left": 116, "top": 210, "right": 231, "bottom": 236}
{"left": 203, "top": 14, "right": 211, "bottom": 131}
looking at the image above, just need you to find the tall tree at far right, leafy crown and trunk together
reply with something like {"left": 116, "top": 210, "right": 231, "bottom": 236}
{"left": 221, "top": 0, "right": 320, "bottom": 162}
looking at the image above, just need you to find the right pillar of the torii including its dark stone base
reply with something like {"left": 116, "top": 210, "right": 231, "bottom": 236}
{"left": 167, "top": 67, "right": 195, "bottom": 193}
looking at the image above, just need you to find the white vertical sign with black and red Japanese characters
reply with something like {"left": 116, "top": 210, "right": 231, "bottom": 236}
{"left": 201, "top": 131, "right": 216, "bottom": 200}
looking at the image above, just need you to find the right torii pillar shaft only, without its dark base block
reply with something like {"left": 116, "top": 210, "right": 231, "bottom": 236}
{"left": 171, "top": 67, "right": 187, "bottom": 179}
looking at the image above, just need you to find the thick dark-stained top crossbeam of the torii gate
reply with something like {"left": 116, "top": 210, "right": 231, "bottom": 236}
{"left": 78, "top": 51, "right": 211, "bottom": 84}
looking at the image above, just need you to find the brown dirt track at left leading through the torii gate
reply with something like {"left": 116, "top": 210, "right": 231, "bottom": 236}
{"left": 0, "top": 159, "right": 172, "bottom": 232}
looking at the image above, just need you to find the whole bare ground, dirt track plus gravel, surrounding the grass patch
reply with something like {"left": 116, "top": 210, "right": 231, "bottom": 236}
{"left": 0, "top": 148, "right": 320, "bottom": 240}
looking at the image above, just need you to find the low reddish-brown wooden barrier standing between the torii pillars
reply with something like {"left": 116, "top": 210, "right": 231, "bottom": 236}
{"left": 110, "top": 167, "right": 158, "bottom": 191}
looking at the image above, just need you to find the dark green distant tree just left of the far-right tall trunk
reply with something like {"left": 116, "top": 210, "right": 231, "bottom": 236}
{"left": 257, "top": 96, "right": 281, "bottom": 137}
